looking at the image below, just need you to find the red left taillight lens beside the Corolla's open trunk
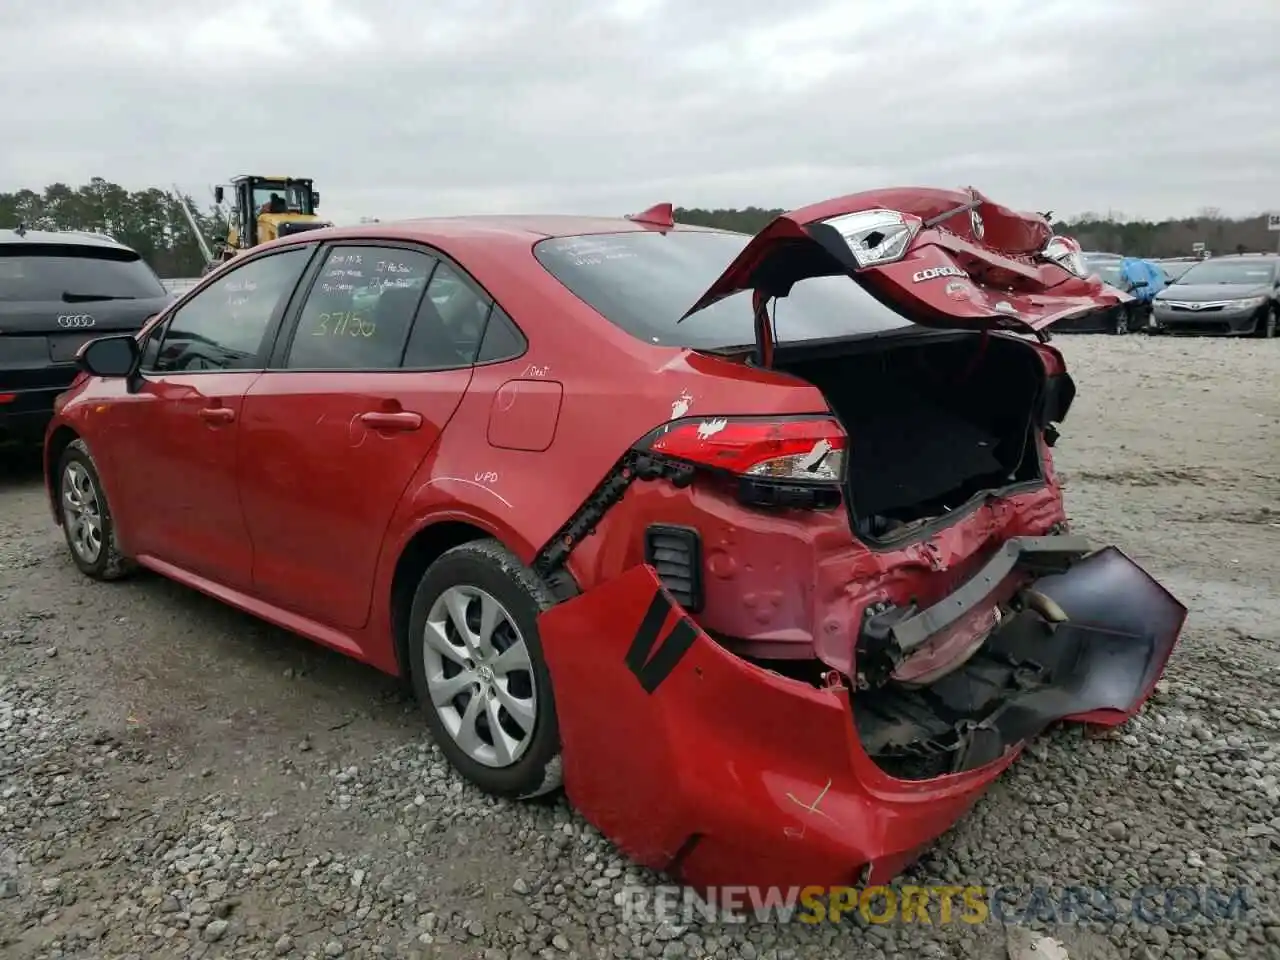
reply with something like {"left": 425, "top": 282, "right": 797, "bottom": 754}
{"left": 641, "top": 416, "right": 847, "bottom": 484}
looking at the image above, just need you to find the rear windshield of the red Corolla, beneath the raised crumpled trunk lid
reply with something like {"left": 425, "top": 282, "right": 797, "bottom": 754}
{"left": 534, "top": 230, "right": 910, "bottom": 349}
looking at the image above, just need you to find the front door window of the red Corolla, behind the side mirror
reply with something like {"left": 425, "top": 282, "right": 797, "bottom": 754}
{"left": 151, "top": 247, "right": 311, "bottom": 372}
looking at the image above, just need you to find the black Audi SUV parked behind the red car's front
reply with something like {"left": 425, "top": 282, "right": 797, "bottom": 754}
{"left": 0, "top": 227, "right": 173, "bottom": 442}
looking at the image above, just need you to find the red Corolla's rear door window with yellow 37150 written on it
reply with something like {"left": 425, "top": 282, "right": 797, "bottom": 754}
{"left": 284, "top": 246, "right": 435, "bottom": 370}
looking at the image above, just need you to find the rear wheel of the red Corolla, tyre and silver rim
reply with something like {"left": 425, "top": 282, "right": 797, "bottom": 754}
{"left": 408, "top": 540, "right": 561, "bottom": 799}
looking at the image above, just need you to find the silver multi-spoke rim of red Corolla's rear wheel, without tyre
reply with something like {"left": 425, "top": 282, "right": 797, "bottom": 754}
{"left": 422, "top": 585, "right": 538, "bottom": 767}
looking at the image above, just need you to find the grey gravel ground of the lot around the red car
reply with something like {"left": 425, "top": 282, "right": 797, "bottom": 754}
{"left": 0, "top": 337, "right": 1280, "bottom": 960}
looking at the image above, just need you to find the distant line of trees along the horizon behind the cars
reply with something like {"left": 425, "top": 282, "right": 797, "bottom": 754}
{"left": 0, "top": 177, "right": 1276, "bottom": 278}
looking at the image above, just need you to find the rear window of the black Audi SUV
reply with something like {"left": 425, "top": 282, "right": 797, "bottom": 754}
{"left": 0, "top": 243, "right": 165, "bottom": 303}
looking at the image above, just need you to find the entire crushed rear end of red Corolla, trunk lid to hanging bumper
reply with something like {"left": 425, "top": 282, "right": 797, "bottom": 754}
{"left": 529, "top": 189, "right": 1187, "bottom": 888}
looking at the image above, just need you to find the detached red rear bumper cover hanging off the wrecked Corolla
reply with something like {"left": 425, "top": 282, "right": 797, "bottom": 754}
{"left": 540, "top": 538, "right": 1185, "bottom": 888}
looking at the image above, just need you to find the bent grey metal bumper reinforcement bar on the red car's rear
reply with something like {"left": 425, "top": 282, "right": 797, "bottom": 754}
{"left": 859, "top": 534, "right": 1091, "bottom": 686}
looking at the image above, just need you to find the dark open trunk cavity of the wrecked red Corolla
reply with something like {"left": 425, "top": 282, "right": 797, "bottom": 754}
{"left": 774, "top": 333, "right": 1046, "bottom": 545}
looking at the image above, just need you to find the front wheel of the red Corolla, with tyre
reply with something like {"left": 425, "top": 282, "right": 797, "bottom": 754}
{"left": 58, "top": 438, "right": 133, "bottom": 580}
